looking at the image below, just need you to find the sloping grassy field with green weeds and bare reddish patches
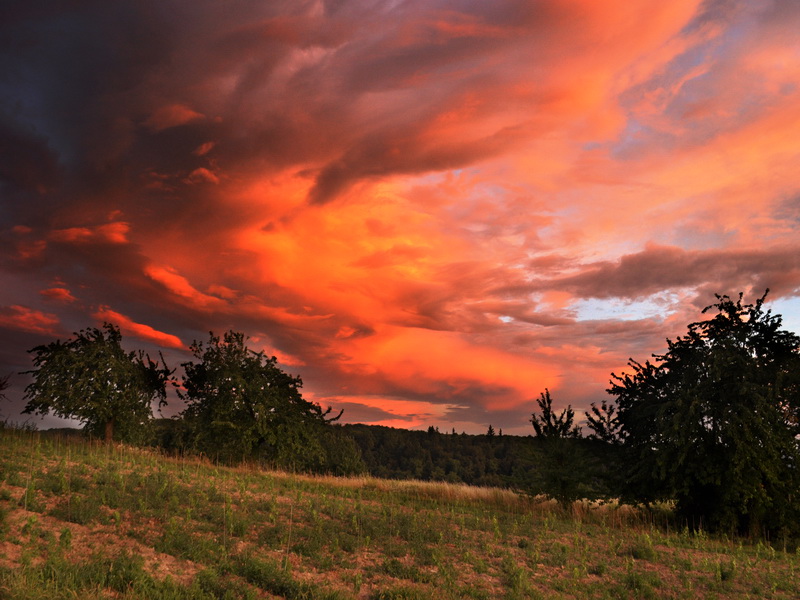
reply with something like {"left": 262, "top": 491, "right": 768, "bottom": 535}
{"left": 0, "top": 429, "right": 800, "bottom": 600}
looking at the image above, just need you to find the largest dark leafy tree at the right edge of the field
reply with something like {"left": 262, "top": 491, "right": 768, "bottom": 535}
{"left": 608, "top": 293, "right": 800, "bottom": 533}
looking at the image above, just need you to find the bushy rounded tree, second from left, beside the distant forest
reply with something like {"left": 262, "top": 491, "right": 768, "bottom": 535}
{"left": 181, "top": 331, "right": 341, "bottom": 470}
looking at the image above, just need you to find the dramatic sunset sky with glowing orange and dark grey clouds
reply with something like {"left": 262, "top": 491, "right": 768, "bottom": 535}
{"left": 0, "top": 0, "right": 800, "bottom": 435}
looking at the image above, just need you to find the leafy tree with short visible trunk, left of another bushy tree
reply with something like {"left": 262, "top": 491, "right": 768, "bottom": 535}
{"left": 22, "top": 323, "right": 172, "bottom": 442}
